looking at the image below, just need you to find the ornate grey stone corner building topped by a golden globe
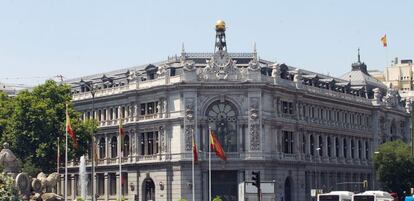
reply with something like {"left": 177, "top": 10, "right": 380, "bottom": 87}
{"left": 61, "top": 22, "right": 410, "bottom": 201}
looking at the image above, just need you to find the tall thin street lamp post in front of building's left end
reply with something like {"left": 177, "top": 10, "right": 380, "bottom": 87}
{"left": 81, "top": 80, "right": 96, "bottom": 201}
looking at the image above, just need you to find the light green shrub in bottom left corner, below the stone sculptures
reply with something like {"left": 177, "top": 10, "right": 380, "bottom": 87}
{"left": 0, "top": 173, "right": 23, "bottom": 201}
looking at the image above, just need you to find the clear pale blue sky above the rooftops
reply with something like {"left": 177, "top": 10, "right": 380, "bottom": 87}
{"left": 0, "top": 0, "right": 414, "bottom": 84}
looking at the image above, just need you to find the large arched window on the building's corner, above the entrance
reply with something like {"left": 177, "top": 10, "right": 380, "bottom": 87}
{"left": 207, "top": 101, "right": 237, "bottom": 152}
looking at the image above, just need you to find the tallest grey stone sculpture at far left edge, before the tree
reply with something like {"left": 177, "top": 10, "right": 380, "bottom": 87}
{"left": 0, "top": 142, "right": 20, "bottom": 173}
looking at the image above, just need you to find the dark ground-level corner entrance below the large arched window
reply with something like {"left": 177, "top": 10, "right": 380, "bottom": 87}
{"left": 211, "top": 171, "right": 238, "bottom": 201}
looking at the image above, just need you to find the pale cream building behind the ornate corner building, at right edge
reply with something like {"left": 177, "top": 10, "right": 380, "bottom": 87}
{"left": 369, "top": 58, "right": 414, "bottom": 100}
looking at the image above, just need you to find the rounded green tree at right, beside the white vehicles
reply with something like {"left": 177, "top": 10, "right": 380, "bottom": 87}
{"left": 374, "top": 140, "right": 414, "bottom": 195}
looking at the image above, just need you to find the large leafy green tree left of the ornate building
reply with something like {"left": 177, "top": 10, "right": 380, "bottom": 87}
{"left": 2, "top": 80, "right": 97, "bottom": 175}
